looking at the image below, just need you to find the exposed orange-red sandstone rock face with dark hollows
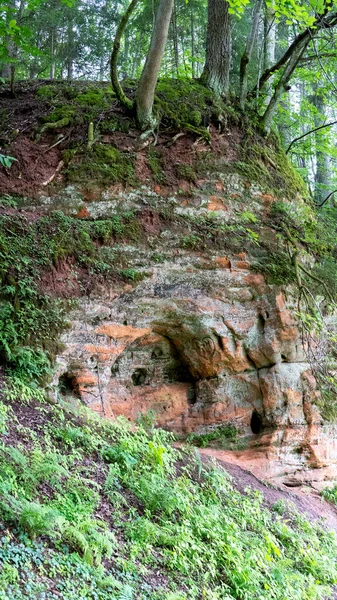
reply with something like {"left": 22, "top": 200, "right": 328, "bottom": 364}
{"left": 47, "top": 176, "right": 337, "bottom": 486}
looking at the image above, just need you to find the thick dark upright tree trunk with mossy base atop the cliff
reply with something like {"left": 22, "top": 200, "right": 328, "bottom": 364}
{"left": 201, "top": 0, "right": 232, "bottom": 98}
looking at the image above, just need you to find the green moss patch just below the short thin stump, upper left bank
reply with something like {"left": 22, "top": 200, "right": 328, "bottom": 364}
{"left": 67, "top": 144, "right": 137, "bottom": 185}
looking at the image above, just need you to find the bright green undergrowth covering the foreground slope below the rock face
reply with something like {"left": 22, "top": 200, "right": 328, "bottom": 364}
{"left": 0, "top": 390, "right": 337, "bottom": 600}
